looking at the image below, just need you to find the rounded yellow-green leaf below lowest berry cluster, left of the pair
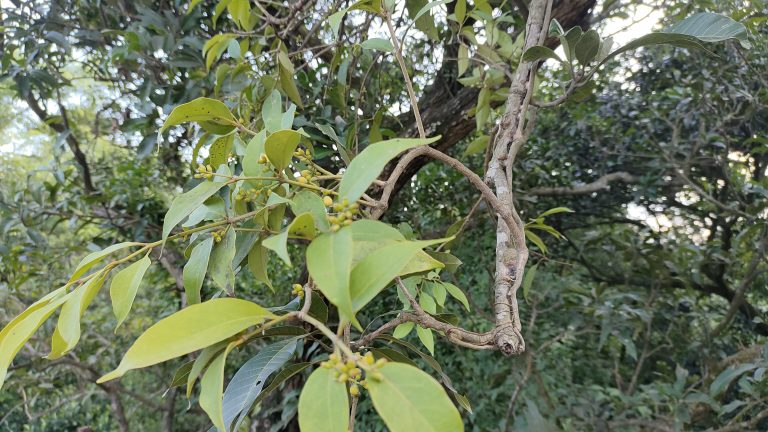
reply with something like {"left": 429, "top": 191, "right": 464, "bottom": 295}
{"left": 299, "top": 368, "right": 349, "bottom": 432}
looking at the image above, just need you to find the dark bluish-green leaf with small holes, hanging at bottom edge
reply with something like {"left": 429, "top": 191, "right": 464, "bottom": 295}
{"left": 223, "top": 338, "right": 298, "bottom": 431}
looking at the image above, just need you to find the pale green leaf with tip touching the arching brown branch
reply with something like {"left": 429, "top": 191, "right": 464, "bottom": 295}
{"left": 339, "top": 136, "right": 440, "bottom": 203}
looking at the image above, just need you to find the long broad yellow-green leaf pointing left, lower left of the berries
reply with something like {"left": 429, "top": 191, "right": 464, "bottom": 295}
{"left": 97, "top": 298, "right": 275, "bottom": 383}
